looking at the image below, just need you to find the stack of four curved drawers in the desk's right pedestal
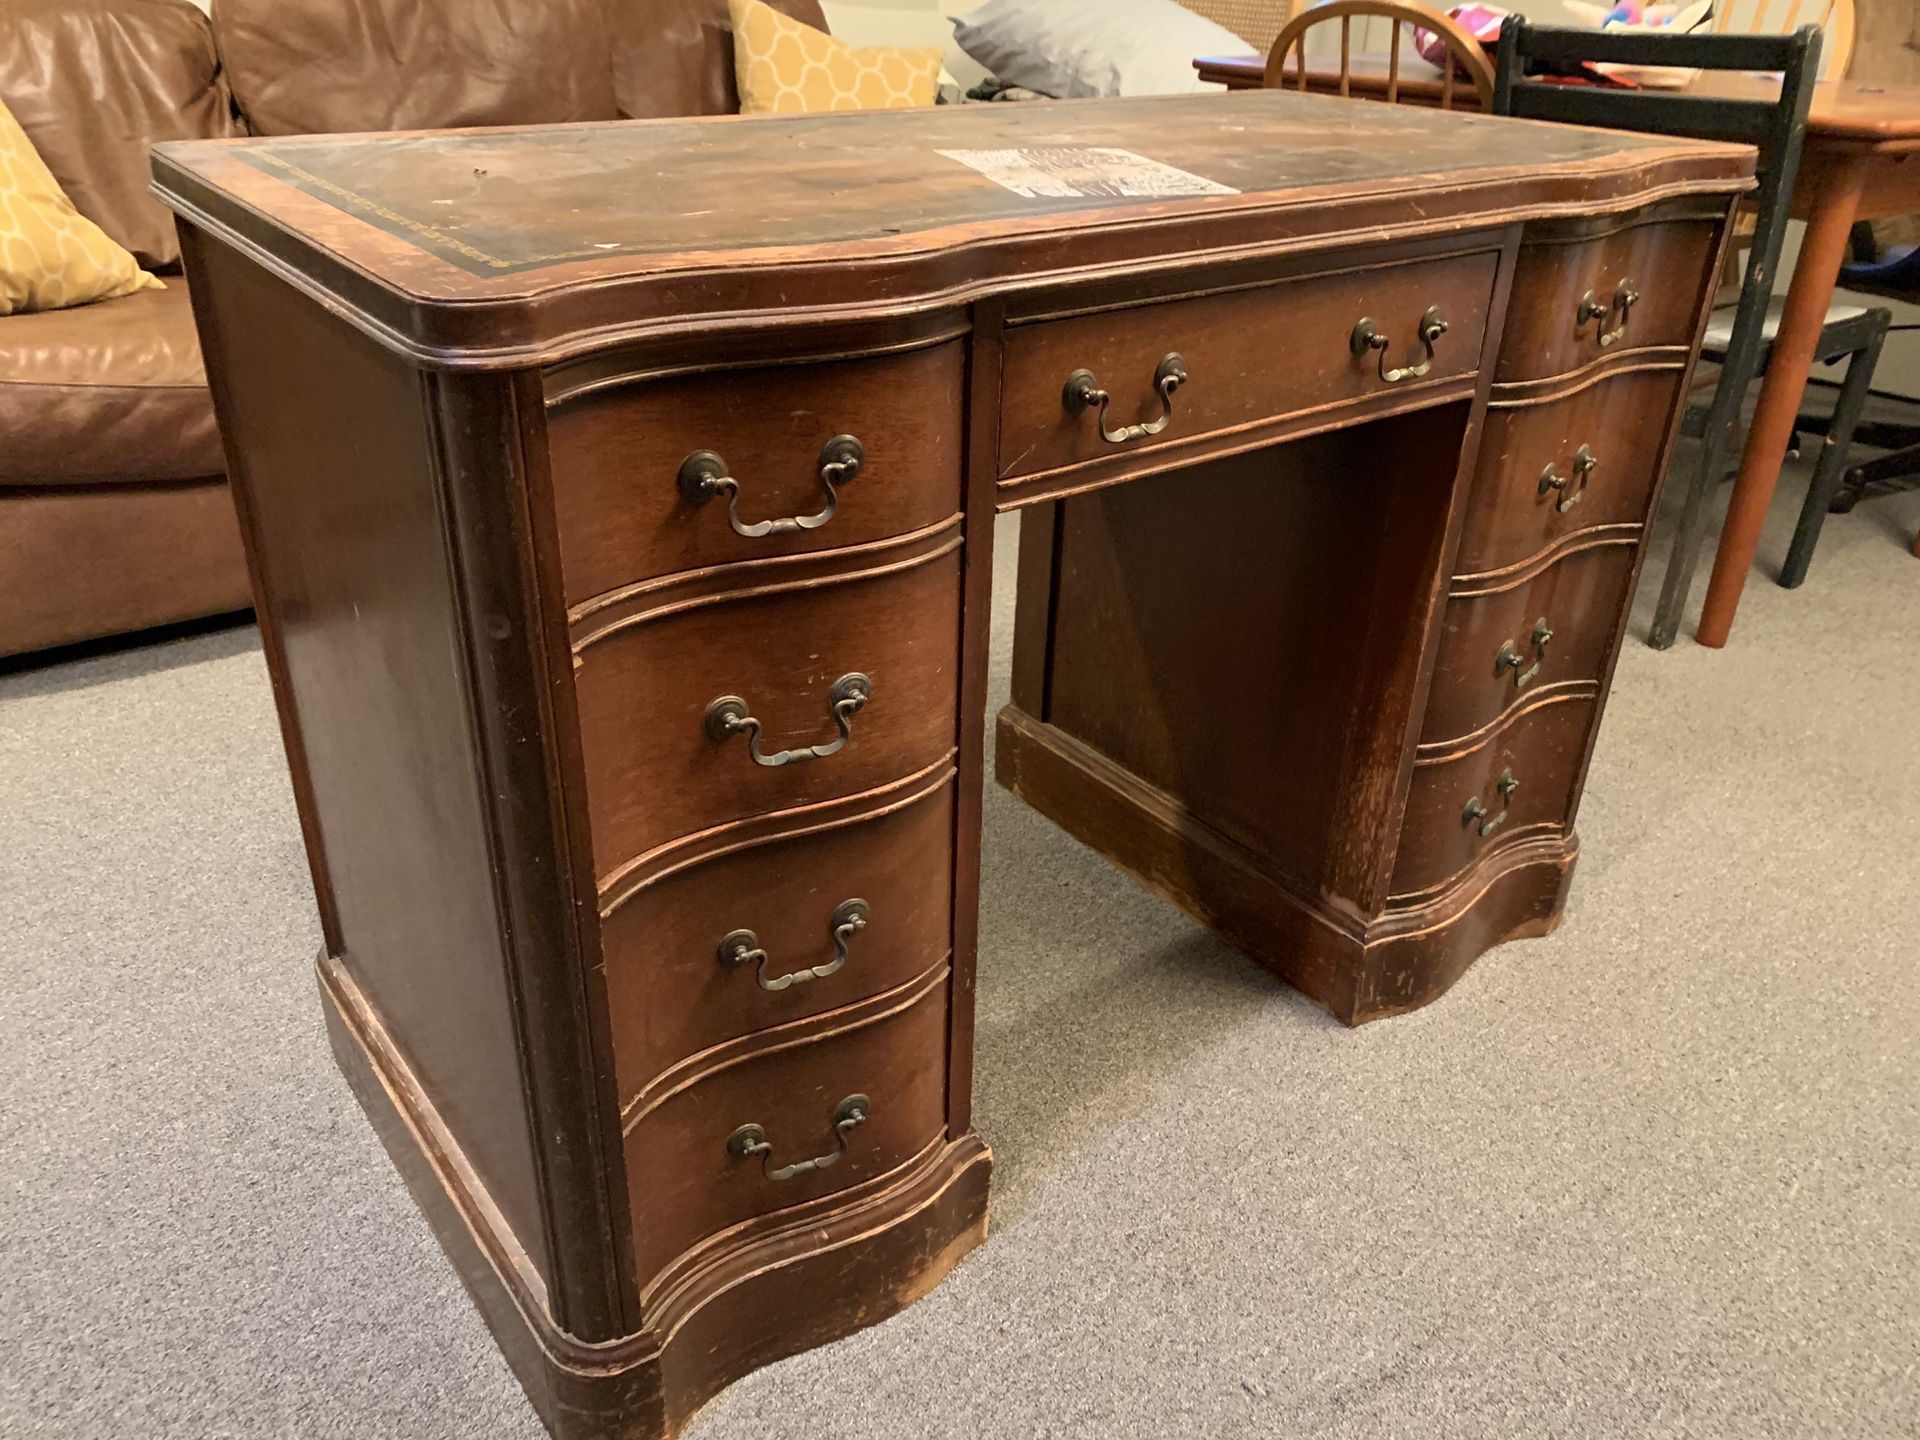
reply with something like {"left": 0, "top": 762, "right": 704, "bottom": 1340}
{"left": 1388, "top": 202, "right": 1718, "bottom": 910}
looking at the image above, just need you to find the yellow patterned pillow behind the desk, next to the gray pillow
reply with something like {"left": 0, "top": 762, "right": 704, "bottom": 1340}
{"left": 728, "top": 0, "right": 941, "bottom": 115}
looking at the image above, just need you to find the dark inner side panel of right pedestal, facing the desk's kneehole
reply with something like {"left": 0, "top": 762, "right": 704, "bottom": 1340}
{"left": 1046, "top": 405, "right": 1467, "bottom": 904}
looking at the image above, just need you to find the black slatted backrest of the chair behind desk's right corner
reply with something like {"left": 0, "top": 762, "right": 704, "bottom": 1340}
{"left": 1494, "top": 15, "right": 1820, "bottom": 439}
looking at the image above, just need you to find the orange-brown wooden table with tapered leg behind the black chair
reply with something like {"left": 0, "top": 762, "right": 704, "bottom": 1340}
{"left": 1194, "top": 56, "right": 1920, "bottom": 649}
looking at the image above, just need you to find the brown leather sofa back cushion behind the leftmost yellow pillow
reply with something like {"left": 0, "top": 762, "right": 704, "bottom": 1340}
{"left": 0, "top": 0, "right": 240, "bottom": 269}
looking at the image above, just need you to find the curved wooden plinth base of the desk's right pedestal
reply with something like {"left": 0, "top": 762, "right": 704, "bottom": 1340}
{"left": 996, "top": 707, "right": 1580, "bottom": 1025}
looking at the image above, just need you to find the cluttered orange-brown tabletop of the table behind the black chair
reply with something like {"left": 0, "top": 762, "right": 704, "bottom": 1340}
{"left": 1194, "top": 56, "right": 1920, "bottom": 148}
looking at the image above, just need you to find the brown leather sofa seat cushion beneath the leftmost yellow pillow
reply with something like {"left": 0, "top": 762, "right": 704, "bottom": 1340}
{"left": 0, "top": 275, "right": 227, "bottom": 488}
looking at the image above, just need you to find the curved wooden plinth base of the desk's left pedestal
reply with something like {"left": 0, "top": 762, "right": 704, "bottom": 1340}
{"left": 319, "top": 956, "right": 993, "bottom": 1440}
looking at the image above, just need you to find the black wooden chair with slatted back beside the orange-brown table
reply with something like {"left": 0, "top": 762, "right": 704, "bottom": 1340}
{"left": 1494, "top": 15, "right": 1891, "bottom": 649}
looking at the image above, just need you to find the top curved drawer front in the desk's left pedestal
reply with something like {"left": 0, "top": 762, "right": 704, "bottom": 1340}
{"left": 547, "top": 342, "right": 964, "bottom": 605}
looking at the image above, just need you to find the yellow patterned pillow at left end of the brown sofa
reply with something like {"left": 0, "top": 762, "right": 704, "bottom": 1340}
{"left": 0, "top": 104, "right": 165, "bottom": 315}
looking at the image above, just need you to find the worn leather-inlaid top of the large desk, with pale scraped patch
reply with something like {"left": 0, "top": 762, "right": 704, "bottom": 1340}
{"left": 154, "top": 92, "right": 1751, "bottom": 363}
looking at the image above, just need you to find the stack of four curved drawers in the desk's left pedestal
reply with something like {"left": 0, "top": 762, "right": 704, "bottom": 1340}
{"left": 547, "top": 340, "right": 964, "bottom": 1304}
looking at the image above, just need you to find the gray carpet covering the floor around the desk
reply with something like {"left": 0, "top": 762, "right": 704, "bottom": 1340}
{"left": 0, "top": 464, "right": 1920, "bottom": 1440}
